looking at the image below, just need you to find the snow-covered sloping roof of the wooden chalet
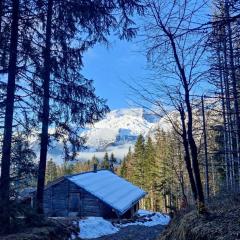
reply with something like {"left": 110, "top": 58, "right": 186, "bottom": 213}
{"left": 67, "top": 170, "right": 146, "bottom": 215}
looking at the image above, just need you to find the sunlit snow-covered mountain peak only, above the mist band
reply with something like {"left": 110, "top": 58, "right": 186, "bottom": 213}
{"left": 82, "top": 108, "right": 156, "bottom": 151}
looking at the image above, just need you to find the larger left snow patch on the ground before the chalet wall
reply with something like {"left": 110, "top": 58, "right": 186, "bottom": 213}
{"left": 79, "top": 217, "right": 119, "bottom": 239}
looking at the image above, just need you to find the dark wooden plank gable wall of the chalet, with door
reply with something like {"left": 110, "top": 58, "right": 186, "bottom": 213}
{"left": 43, "top": 178, "right": 119, "bottom": 218}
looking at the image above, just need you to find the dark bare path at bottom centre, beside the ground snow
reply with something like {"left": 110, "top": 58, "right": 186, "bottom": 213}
{"left": 89, "top": 225, "right": 165, "bottom": 240}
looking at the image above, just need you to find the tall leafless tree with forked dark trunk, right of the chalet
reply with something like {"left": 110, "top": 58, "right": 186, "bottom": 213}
{"left": 129, "top": 0, "right": 212, "bottom": 213}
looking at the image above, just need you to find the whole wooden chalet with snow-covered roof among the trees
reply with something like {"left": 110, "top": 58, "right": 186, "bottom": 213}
{"left": 43, "top": 170, "right": 146, "bottom": 218}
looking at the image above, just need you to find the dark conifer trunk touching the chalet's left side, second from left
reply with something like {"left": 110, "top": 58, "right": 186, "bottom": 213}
{"left": 36, "top": 0, "right": 53, "bottom": 213}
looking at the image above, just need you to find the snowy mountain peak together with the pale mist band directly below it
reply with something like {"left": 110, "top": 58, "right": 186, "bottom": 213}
{"left": 78, "top": 108, "right": 159, "bottom": 159}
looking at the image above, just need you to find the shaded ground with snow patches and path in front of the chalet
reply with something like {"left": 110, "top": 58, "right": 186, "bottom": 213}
{"left": 0, "top": 210, "right": 170, "bottom": 240}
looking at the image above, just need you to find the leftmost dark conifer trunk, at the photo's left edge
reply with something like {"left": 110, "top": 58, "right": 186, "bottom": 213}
{"left": 0, "top": 0, "right": 19, "bottom": 226}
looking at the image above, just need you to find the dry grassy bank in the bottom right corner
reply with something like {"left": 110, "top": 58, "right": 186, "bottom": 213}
{"left": 159, "top": 195, "right": 240, "bottom": 240}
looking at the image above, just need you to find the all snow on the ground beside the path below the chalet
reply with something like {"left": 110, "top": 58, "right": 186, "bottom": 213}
{"left": 79, "top": 210, "right": 170, "bottom": 239}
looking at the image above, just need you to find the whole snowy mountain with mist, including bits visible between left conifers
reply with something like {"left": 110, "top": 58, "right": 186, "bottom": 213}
{"left": 34, "top": 108, "right": 171, "bottom": 163}
